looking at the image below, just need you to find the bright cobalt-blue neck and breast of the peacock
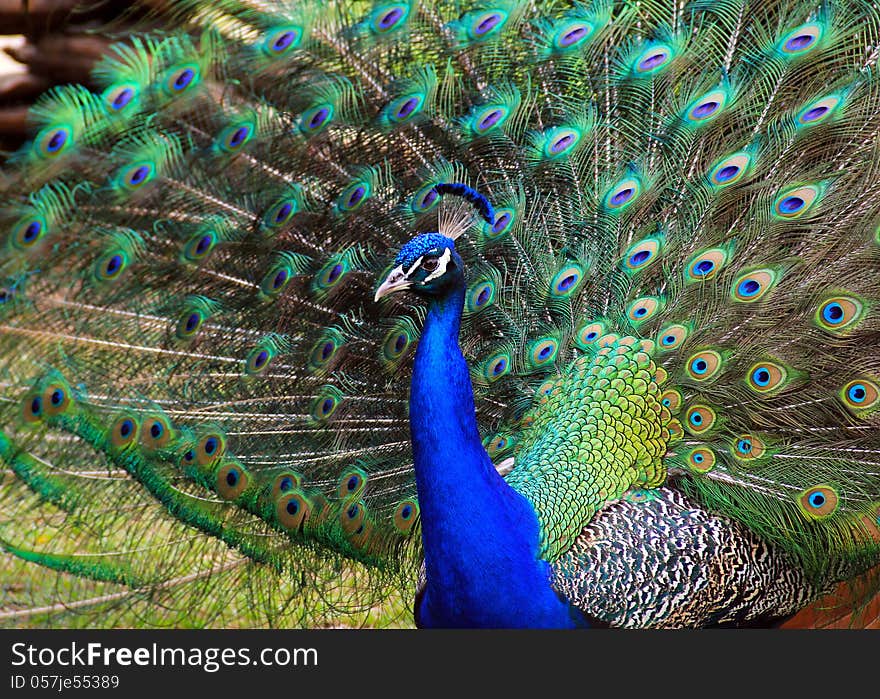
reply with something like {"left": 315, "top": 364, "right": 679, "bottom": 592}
{"left": 410, "top": 280, "right": 583, "bottom": 628}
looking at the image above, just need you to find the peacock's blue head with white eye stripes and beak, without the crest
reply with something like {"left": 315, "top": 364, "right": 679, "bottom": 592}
{"left": 376, "top": 233, "right": 464, "bottom": 301}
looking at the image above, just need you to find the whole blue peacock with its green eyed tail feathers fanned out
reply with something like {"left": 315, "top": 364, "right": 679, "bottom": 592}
{"left": 0, "top": 0, "right": 880, "bottom": 628}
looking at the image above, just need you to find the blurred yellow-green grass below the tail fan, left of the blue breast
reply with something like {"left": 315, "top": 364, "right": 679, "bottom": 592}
{"left": 0, "top": 472, "right": 416, "bottom": 628}
